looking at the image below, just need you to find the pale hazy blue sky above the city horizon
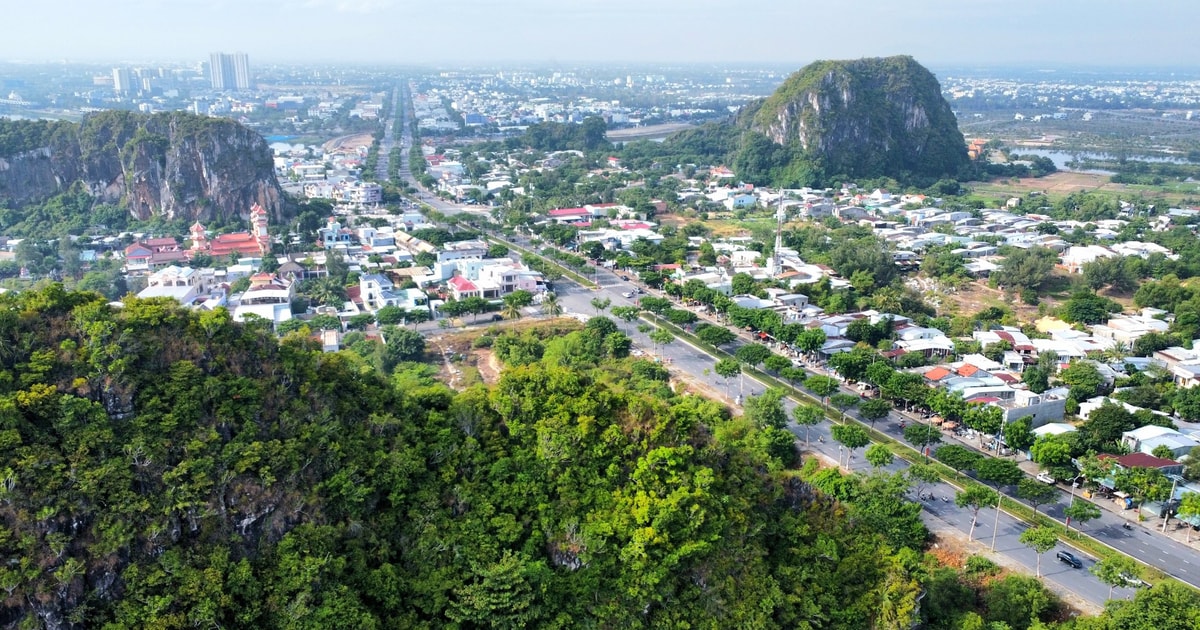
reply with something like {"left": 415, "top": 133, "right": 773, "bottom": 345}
{"left": 9, "top": 0, "right": 1200, "bottom": 67}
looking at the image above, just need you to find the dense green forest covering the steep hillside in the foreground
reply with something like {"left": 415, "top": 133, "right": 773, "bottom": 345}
{"left": 0, "top": 284, "right": 1196, "bottom": 630}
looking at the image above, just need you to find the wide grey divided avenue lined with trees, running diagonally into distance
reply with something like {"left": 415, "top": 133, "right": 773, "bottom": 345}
{"left": 384, "top": 88, "right": 1152, "bottom": 610}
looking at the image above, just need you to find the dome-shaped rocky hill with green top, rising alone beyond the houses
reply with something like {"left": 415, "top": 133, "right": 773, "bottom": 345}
{"left": 740, "top": 56, "right": 967, "bottom": 176}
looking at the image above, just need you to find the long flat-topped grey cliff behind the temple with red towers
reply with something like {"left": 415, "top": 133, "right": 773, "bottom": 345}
{"left": 0, "top": 112, "right": 283, "bottom": 221}
